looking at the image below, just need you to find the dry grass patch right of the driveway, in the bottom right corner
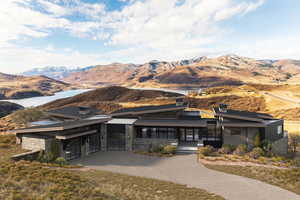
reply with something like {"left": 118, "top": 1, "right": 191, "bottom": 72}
{"left": 205, "top": 165, "right": 300, "bottom": 195}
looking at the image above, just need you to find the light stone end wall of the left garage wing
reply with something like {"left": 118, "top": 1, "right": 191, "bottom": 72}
{"left": 22, "top": 136, "right": 53, "bottom": 151}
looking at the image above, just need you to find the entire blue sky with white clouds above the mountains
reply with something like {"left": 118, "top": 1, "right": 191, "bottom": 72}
{"left": 0, "top": 0, "right": 300, "bottom": 73}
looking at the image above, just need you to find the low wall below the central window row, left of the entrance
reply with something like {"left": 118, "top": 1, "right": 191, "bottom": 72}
{"left": 133, "top": 138, "right": 178, "bottom": 151}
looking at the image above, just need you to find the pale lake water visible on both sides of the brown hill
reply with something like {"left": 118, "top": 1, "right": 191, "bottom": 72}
{"left": 3, "top": 88, "right": 192, "bottom": 108}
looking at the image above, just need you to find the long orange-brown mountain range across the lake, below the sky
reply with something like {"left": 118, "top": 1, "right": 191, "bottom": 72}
{"left": 63, "top": 55, "right": 300, "bottom": 88}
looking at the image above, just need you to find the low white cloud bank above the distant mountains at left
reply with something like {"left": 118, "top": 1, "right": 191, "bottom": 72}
{"left": 0, "top": 45, "right": 106, "bottom": 73}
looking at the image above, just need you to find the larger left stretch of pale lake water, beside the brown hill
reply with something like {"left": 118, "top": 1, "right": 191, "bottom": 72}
{"left": 4, "top": 89, "right": 90, "bottom": 108}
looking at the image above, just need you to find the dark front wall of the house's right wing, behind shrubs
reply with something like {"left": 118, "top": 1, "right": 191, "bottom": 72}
{"left": 223, "top": 127, "right": 259, "bottom": 147}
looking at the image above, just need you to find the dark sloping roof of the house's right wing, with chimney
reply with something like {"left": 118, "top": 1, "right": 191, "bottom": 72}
{"left": 213, "top": 108, "right": 274, "bottom": 122}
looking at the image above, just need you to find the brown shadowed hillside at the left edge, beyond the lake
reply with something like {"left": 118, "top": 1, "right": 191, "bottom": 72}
{"left": 0, "top": 74, "right": 71, "bottom": 100}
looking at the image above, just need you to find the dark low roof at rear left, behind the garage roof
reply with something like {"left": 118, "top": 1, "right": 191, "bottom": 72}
{"left": 47, "top": 106, "right": 102, "bottom": 119}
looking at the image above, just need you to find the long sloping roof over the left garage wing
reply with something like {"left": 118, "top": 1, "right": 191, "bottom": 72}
{"left": 9, "top": 118, "right": 110, "bottom": 134}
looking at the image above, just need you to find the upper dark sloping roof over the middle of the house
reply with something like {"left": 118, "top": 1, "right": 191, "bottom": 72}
{"left": 111, "top": 104, "right": 187, "bottom": 116}
